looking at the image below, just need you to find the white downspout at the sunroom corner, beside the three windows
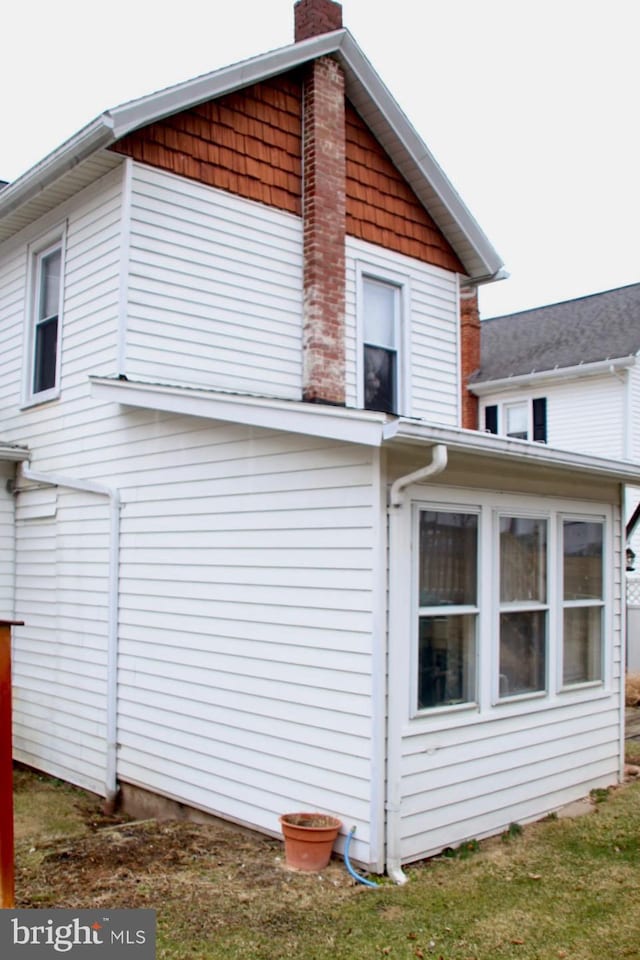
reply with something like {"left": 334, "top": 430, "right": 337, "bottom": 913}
{"left": 386, "top": 443, "right": 447, "bottom": 884}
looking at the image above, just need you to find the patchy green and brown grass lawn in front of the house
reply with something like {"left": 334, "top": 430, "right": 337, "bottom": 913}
{"left": 16, "top": 768, "right": 640, "bottom": 960}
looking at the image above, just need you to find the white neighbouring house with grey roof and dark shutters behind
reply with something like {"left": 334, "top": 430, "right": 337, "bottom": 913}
{"left": 470, "top": 283, "right": 640, "bottom": 669}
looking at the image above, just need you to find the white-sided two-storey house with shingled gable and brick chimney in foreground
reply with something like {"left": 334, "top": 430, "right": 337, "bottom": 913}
{"left": 0, "top": 0, "right": 640, "bottom": 880}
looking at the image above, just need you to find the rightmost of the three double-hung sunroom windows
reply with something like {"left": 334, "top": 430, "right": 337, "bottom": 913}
{"left": 562, "top": 518, "right": 604, "bottom": 686}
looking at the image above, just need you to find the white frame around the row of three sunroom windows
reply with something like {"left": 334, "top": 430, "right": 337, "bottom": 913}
{"left": 408, "top": 487, "right": 617, "bottom": 734}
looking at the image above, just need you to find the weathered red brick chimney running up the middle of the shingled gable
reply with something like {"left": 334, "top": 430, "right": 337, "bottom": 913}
{"left": 294, "top": 0, "right": 346, "bottom": 406}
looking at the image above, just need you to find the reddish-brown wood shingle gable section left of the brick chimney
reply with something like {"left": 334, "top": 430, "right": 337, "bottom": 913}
{"left": 113, "top": 75, "right": 302, "bottom": 214}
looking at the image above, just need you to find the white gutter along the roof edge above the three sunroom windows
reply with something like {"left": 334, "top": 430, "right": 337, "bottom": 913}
{"left": 384, "top": 418, "right": 640, "bottom": 486}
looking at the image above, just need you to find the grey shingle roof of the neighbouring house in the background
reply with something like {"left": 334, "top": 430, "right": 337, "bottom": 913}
{"left": 471, "top": 283, "right": 640, "bottom": 385}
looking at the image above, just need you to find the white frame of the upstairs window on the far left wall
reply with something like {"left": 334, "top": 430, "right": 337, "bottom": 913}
{"left": 22, "top": 225, "right": 66, "bottom": 407}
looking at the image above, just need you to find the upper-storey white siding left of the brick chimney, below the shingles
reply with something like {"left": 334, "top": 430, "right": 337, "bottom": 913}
{"left": 126, "top": 164, "right": 302, "bottom": 399}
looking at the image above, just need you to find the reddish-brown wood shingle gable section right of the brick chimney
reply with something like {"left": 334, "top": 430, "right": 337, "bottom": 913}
{"left": 346, "top": 102, "right": 464, "bottom": 273}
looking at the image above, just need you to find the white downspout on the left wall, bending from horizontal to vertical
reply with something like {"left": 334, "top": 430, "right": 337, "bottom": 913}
{"left": 18, "top": 463, "right": 121, "bottom": 813}
